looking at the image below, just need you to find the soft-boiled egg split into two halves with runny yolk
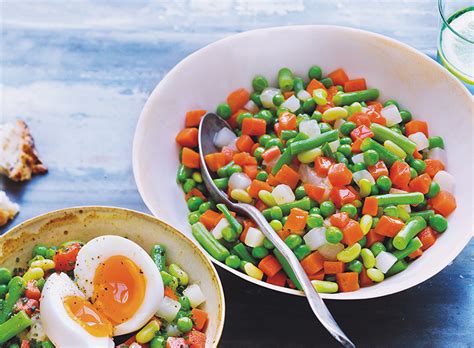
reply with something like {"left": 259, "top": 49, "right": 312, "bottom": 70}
{"left": 41, "top": 236, "right": 164, "bottom": 347}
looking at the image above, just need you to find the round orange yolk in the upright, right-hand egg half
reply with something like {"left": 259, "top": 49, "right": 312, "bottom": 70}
{"left": 92, "top": 256, "right": 146, "bottom": 325}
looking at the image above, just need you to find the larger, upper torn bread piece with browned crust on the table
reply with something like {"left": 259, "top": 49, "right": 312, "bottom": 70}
{"left": 0, "top": 120, "right": 48, "bottom": 181}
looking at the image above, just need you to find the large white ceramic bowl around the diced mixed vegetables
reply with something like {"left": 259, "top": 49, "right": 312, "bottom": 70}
{"left": 133, "top": 26, "right": 474, "bottom": 299}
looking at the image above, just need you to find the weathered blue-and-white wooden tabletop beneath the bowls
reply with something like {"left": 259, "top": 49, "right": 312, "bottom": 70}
{"left": 0, "top": 0, "right": 474, "bottom": 347}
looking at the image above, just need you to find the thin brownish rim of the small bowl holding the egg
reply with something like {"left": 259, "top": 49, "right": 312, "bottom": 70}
{"left": 0, "top": 205, "right": 226, "bottom": 347}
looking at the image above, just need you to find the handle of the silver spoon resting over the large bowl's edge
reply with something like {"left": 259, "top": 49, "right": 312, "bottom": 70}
{"left": 241, "top": 203, "right": 355, "bottom": 347}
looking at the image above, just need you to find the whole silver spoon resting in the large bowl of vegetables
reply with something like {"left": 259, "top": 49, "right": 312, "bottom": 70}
{"left": 199, "top": 113, "right": 355, "bottom": 347}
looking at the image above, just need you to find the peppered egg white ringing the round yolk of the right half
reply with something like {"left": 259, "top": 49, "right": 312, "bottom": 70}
{"left": 74, "top": 236, "right": 164, "bottom": 336}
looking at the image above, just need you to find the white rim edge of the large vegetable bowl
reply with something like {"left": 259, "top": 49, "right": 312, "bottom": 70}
{"left": 132, "top": 25, "right": 474, "bottom": 300}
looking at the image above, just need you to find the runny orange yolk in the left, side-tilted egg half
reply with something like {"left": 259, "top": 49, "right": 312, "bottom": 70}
{"left": 63, "top": 296, "right": 113, "bottom": 337}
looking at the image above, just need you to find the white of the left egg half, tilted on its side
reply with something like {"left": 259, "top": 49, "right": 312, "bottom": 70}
{"left": 40, "top": 273, "right": 115, "bottom": 348}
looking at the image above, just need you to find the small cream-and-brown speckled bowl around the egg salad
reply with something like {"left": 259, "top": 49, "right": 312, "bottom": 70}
{"left": 0, "top": 207, "right": 225, "bottom": 347}
